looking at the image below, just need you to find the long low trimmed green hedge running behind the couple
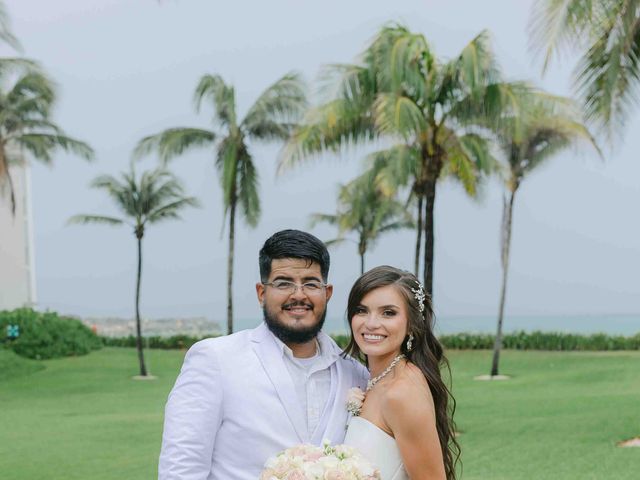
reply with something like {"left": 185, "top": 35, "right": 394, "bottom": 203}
{"left": 103, "top": 332, "right": 640, "bottom": 351}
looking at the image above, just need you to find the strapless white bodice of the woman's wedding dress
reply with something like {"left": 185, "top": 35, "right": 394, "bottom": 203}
{"left": 344, "top": 417, "right": 409, "bottom": 480}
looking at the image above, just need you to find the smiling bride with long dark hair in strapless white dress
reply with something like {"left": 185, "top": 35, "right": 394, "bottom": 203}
{"left": 344, "top": 266, "right": 460, "bottom": 480}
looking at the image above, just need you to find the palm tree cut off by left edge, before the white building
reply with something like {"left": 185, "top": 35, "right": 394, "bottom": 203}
{"left": 0, "top": 69, "right": 93, "bottom": 214}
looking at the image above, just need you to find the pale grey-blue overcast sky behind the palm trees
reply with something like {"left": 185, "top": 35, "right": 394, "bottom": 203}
{"left": 3, "top": 0, "right": 640, "bottom": 332}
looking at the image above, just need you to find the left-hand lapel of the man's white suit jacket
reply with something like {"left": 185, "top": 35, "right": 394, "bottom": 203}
{"left": 252, "top": 323, "right": 309, "bottom": 443}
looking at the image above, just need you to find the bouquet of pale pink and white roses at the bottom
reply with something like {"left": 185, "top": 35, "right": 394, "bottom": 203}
{"left": 260, "top": 441, "right": 380, "bottom": 480}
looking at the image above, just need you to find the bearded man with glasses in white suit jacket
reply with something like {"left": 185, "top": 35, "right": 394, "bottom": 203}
{"left": 158, "top": 230, "right": 368, "bottom": 480}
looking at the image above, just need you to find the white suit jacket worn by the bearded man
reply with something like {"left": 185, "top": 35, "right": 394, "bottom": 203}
{"left": 158, "top": 323, "right": 369, "bottom": 480}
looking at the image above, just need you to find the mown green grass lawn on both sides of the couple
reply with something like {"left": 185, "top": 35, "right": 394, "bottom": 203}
{"left": 0, "top": 348, "right": 640, "bottom": 480}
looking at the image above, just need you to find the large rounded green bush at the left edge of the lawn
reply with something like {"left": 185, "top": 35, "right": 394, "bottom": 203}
{"left": 0, "top": 308, "right": 102, "bottom": 360}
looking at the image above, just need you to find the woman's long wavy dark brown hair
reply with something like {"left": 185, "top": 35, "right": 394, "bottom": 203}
{"left": 345, "top": 265, "right": 460, "bottom": 480}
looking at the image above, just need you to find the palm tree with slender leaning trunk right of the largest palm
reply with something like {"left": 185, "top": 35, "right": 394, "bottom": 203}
{"left": 484, "top": 90, "right": 600, "bottom": 376}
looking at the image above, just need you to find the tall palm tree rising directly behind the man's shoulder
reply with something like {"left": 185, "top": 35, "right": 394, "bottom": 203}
{"left": 134, "top": 74, "right": 306, "bottom": 333}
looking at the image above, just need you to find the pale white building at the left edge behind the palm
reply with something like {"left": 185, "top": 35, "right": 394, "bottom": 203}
{"left": 0, "top": 162, "right": 36, "bottom": 310}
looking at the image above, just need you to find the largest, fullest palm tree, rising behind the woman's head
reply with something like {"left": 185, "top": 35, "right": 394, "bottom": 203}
{"left": 280, "top": 25, "right": 513, "bottom": 293}
